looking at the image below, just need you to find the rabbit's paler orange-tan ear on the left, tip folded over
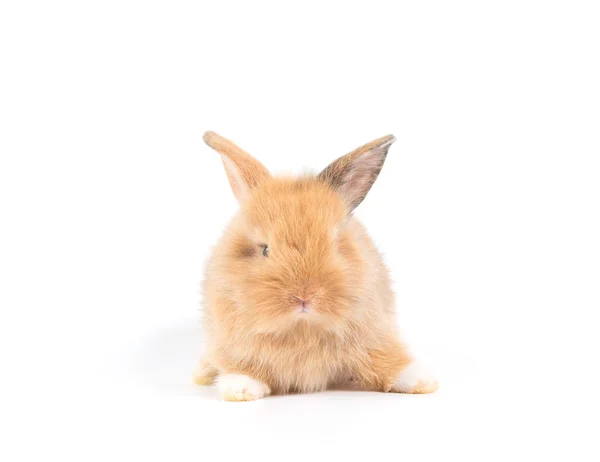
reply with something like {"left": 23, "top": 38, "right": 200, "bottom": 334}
{"left": 204, "top": 132, "right": 270, "bottom": 203}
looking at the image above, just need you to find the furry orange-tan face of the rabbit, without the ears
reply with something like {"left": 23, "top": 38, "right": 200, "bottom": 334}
{"left": 230, "top": 178, "right": 362, "bottom": 330}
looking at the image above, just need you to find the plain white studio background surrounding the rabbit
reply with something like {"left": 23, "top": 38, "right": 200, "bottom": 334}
{"left": 0, "top": 0, "right": 600, "bottom": 461}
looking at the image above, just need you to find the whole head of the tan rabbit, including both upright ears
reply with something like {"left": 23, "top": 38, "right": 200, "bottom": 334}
{"left": 204, "top": 132, "right": 395, "bottom": 332}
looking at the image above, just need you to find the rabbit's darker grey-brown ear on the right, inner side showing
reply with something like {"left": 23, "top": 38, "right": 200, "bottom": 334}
{"left": 318, "top": 135, "right": 396, "bottom": 211}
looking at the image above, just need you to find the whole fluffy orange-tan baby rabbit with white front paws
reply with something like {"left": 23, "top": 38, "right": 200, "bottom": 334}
{"left": 194, "top": 131, "right": 438, "bottom": 401}
